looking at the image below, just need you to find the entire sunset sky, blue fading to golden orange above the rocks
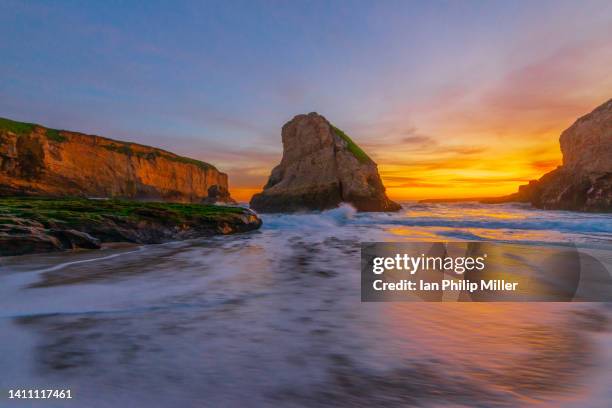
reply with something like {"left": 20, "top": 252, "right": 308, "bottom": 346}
{"left": 0, "top": 0, "right": 612, "bottom": 201}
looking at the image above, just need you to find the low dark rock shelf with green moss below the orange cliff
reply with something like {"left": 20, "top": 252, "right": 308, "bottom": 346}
{"left": 0, "top": 197, "right": 261, "bottom": 256}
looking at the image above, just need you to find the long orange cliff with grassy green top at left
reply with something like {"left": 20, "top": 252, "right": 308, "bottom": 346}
{"left": 0, "top": 118, "right": 231, "bottom": 202}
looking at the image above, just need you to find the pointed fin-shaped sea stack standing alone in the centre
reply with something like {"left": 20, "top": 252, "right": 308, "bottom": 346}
{"left": 251, "top": 112, "right": 401, "bottom": 212}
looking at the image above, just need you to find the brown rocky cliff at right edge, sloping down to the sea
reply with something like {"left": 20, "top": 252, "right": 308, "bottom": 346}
{"left": 492, "top": 99, "right": 612, "bottom": 212}
